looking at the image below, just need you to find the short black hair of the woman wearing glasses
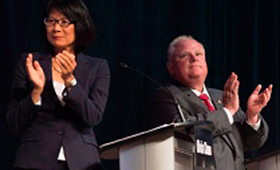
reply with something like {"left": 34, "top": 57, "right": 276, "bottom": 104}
{"left": 45, "top": 0, "right": 95, "bottom": 53}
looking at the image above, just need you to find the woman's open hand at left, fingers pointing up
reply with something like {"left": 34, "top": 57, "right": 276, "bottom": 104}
{"left": 26, "top": 53, "right": 45, "bottom": 103}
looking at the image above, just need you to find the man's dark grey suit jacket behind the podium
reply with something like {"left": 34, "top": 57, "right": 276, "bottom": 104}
{"left": 147, "top": 82, "right": 268, "bottom": 170}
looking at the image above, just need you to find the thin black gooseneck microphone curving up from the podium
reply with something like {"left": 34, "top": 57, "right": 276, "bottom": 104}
{"left": 119, "top": 62, "right": 186, "bottom": 122}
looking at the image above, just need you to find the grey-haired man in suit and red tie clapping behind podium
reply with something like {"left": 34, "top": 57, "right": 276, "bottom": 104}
{"left": 148, "top": 36, "right": 272, "bottom": 170}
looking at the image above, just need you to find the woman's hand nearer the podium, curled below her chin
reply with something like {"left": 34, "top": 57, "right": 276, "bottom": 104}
{"left": 55, "top": 51, "right": 77, "bottom": 86}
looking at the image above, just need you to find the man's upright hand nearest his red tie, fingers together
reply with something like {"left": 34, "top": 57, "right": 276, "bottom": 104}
{"left": 223, "top": 73, "right": 240, "bottom": 115}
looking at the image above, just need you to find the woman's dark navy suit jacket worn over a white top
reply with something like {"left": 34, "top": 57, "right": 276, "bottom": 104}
{"left": 6, "top": 53, "right": 110, "bottom": 170}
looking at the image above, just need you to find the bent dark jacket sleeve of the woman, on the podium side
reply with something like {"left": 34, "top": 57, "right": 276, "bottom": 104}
{"left": 64, "top": 60, "right": 110, "bottom": 127}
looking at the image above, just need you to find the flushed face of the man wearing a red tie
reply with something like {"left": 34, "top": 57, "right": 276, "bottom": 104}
{"left": 167, "top": 39, "right": 208, "bottom": 86}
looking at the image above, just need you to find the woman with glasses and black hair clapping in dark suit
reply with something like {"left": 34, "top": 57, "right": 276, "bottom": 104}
{"left": 7, "top": 0, "right": 110, "bottom": 170}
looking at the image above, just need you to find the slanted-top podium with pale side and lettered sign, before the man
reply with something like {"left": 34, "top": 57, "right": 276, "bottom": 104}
{"left": 100, "top": 121, "right": 215, "bottom": 170}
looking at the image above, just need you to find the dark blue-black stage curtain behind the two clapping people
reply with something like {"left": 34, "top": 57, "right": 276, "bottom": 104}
{"left": 0, "top": 0, "right": 280, "bottom": 170}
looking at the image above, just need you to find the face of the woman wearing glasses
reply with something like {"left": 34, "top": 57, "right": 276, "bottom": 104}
{"left": 46, "top": 10, "right": 75, "bottom": 53}
